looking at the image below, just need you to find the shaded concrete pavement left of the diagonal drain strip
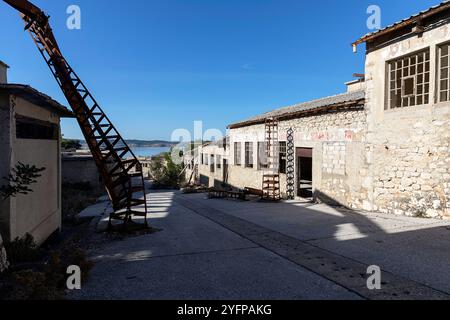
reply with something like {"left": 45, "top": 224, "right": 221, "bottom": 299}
{"left": 69, "top": 192, "right": 359, "bottom": 299}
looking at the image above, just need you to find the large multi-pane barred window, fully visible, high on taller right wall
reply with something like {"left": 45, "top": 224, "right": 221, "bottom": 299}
{"left": 386, "top": 49, "right": 428, "bottom": 109}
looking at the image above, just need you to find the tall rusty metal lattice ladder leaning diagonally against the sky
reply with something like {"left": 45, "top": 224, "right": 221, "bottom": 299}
{"left": 22, "top": 14, "right": 148, "bottom": 227}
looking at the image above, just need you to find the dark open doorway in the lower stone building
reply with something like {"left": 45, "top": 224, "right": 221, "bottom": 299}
{"left": 297, "top": 148, "right": 313, "bottom": 198}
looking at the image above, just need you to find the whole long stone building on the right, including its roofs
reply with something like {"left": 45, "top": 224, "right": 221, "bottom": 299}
{"left": 187, "top": 2, "right": 450, "bottom": 217}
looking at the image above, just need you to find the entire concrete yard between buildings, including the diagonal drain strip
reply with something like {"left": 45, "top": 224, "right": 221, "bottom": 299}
{"left": 69, "top": 192, "right": 450, "bottom": 299}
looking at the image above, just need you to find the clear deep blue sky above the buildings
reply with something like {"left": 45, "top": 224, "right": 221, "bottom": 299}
{"left": 0, "top": 0, "right": 439, "bottom": 140}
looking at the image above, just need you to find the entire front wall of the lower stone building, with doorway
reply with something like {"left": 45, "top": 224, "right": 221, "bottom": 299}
{"left": 230, "top": 107, "right": 367, "bottom": 204}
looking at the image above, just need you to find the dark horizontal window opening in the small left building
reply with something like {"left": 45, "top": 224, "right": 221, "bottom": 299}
{"left": 16, "top": 116, "right": 59, "bottom": 140}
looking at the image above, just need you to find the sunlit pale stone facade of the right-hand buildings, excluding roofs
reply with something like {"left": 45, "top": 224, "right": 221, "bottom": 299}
{"left": 184, "top": 4, "right": 450, "bottom": 218}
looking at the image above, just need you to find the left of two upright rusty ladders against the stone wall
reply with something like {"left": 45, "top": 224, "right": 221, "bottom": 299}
{"left": 262, "top": 118, "right": 281, "bottom": 201}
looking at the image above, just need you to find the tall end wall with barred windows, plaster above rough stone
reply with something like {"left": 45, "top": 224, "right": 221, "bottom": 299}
{"left": 365, "top": 24, "right": 450, "bottom": 217}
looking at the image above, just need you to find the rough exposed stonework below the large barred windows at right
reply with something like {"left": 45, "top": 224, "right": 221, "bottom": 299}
{"left": 372, "top": 105, "right": 450, "bottom": 217}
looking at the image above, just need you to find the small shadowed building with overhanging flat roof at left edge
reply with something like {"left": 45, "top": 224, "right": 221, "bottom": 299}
{"left": 0, "top": 62, "right": 73, "bottom": 244}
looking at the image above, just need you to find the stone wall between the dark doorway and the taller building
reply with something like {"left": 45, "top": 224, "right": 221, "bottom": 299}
{"left": 280, "top": 106, "right": 367, "bottom": 209}
